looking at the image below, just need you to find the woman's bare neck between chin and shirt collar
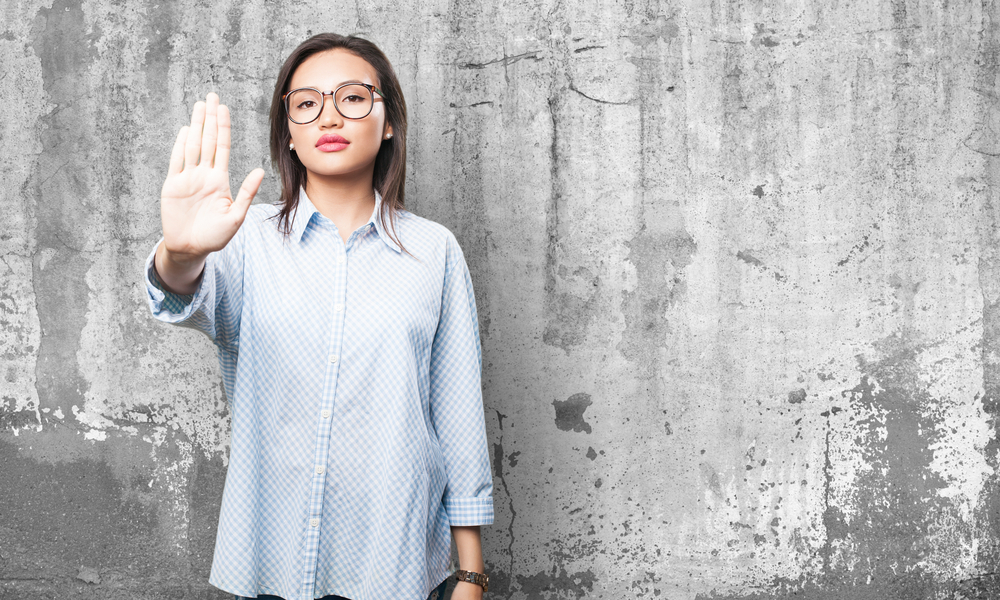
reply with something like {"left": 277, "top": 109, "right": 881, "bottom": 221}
{"left": 305, "top": 166, "right": 375, "bottom": 231}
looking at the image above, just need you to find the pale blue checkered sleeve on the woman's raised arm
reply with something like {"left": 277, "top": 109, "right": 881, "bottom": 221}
{"left": 144, "top": 228, "right": 243, "bottom": 353}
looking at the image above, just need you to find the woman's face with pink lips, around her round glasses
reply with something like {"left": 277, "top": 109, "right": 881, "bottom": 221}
{"left": 288, "top": 48, "right": 392, "bottom": 177}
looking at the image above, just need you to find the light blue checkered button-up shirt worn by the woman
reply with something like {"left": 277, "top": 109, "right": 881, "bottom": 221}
{"left": 145, "top": 190, "right": 493, "bottom": 600}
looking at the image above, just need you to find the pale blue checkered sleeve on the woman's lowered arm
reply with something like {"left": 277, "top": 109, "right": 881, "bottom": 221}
{"left": 430, "top": 235, "right": 493, "bottom": 525}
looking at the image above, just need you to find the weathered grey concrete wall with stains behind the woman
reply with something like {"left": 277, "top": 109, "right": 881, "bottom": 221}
{"left": 0, "top": 0, "right": 1000, "bottom": 600}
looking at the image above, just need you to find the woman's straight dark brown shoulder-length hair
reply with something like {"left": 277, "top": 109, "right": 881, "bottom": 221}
{"left": 271, "top": 33, "right": 409, "bottom": 254}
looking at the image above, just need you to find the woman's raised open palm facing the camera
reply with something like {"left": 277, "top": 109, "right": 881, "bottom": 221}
{"left": 160, "top": 93, "right": 264, "bottom": 257}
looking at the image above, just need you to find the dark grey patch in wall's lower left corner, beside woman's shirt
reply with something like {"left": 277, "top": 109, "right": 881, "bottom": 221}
{"left": 0, "top": 432, "right": 231, "bottom": 600}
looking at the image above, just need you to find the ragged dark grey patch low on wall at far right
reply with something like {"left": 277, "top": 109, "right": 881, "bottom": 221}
{"left": 728, "top": 335, "right": 960, "bottom": 600}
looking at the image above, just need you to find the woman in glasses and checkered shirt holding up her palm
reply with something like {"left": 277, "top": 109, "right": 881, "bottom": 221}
{"left": 145, "top": 34, "right": 493, "bottom": 600}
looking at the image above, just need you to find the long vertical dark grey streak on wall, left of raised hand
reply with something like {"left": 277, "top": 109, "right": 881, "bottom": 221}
{"left": 28, "top": 0, "right": 100, "bottom": 422}
